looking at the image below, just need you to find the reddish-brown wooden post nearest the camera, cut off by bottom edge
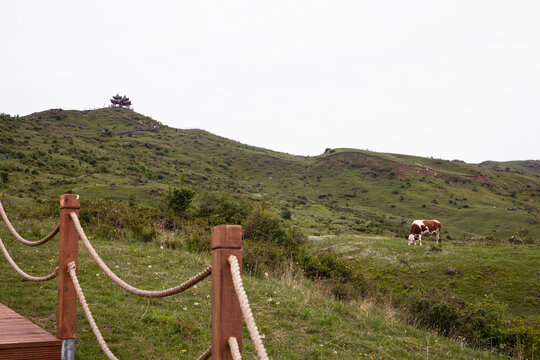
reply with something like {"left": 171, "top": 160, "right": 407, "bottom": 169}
{"left": 212, "top": 225, "right": 242, "bottom": 360}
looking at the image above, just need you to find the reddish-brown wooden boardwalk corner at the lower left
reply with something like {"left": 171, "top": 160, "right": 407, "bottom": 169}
{"left": 0, "top": 304, "right": 62, "bottom": 360}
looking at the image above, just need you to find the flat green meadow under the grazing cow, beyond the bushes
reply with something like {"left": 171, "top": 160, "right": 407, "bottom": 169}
{"left": 310, "top": 235, "right": 540, "bottom": 321}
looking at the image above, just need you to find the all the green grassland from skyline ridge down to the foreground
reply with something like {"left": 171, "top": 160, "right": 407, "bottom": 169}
{"left": 0, "top": 109, "right": 540, "bottom": 359}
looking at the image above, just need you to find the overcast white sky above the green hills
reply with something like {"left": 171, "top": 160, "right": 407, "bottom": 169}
{"left": 0, "top": 0, "right": 540, "bottom": 162}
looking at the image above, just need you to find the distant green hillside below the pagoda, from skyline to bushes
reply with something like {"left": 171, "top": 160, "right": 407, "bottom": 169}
{"left": 0, "top": 108, "right": 540, "bottom": 241}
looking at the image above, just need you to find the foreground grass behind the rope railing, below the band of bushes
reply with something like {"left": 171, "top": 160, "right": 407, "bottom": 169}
{"left": 0, "top": 221, "right": 504, "bottom": 359}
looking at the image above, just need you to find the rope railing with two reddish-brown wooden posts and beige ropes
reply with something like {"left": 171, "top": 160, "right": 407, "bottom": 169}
{"left": 0, "top": 194, "right": 268, "bottom": 360}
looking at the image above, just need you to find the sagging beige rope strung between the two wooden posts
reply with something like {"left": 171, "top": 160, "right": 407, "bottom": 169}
{"left": 69, "top": 212, "right": 212, "bottom": 298}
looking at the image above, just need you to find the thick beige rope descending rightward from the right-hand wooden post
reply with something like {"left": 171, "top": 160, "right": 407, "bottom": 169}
{"left": 228, "top": 255, "right": 268, "bottom": 360}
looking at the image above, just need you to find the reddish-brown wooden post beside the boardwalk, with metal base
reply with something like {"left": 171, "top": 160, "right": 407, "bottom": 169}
{"left": 56, "top": 194, "right": 79, "bottom": 359}
